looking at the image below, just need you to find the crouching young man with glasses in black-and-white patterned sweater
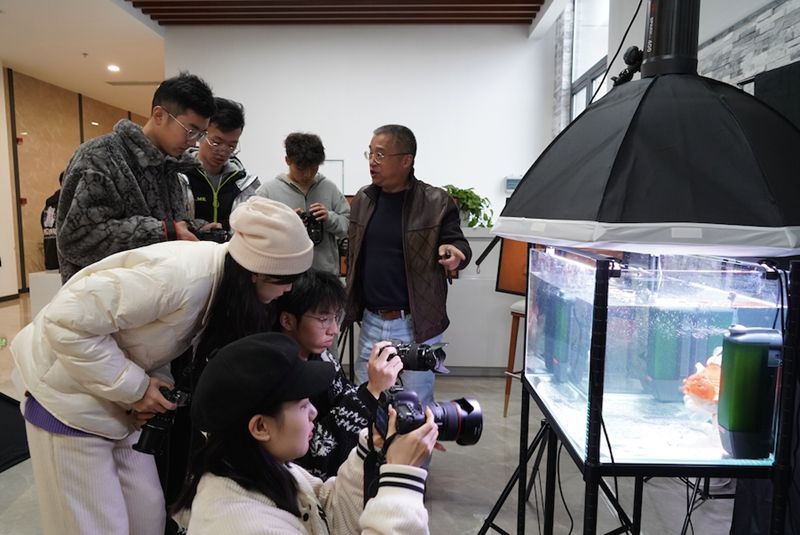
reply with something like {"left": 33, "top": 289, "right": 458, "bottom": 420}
{"left": 278, "top": 269, "right": 403, "bottom": 479}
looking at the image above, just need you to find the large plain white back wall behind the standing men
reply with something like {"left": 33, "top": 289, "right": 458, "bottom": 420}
{"left": 164, "top": 25, "right": 553, "bottom": 214}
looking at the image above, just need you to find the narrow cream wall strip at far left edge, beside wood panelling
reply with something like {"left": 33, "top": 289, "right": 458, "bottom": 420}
{"left": 0, "top": 63, "right": 19, "bottom": 297}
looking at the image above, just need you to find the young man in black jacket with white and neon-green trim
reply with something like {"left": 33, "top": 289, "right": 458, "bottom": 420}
{"left": 181, "top": 97, "right": 261, "bottom": 236}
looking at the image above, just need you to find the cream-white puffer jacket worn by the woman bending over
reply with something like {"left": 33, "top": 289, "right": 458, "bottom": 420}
{"left": 11, "top": 241, "right": 227, "bottom": 439}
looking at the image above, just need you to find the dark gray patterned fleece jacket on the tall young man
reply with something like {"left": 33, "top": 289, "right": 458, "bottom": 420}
{"left": 56, "top": 119, "right": 197, "bottom": 282}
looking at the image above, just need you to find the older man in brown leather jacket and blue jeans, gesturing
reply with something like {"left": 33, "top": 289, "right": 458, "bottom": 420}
{"left": 345, "top": 125, "right": 472, "bottom": 410}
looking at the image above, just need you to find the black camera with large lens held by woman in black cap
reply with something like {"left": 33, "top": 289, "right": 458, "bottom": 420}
{"left": 375, "top": 386, "right": 483, "bottom": 446}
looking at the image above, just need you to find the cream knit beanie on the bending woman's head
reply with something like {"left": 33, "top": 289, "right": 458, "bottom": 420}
{"left": 228, "top": 196, "right": 314, "bottom": 275}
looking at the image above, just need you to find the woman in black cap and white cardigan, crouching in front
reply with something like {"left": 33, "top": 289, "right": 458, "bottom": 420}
{"left": 172, "top": 333, "right": 438, "bottom": 535}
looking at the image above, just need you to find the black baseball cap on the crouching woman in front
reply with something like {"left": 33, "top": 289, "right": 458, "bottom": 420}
{"left": 191, "top": 333, "right": 334, "bottom": 432}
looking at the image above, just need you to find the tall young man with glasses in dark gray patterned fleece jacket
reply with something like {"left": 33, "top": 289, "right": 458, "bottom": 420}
{"left": 56, "top": 73, "right": 214, "bottom": 282}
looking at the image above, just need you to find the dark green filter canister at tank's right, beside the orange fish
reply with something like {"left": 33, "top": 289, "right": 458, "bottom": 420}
{"left": 717, "top": 325, "right": 783, "bottom": 459}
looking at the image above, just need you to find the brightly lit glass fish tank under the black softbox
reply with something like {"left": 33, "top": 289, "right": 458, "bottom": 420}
{"left": 525, "top": 246, "right": 786, "bottom": 466}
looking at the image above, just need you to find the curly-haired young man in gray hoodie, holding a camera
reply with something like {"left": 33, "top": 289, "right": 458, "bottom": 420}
{"left": 256, "top": 132, "right": 350, "bottom": 275}
